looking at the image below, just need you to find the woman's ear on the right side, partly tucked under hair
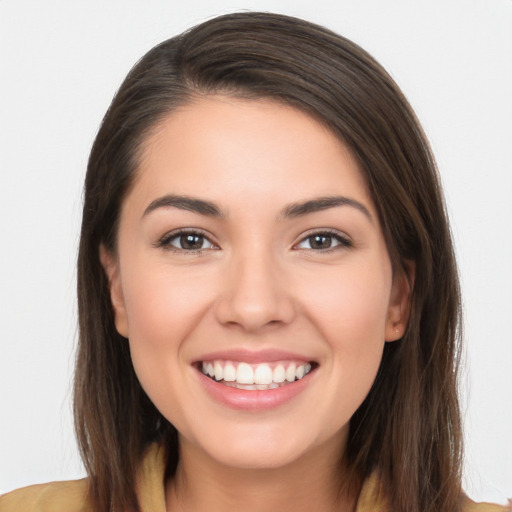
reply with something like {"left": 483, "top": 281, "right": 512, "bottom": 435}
{"left": 385, "top": 261, "right": 416, "bottom": 341}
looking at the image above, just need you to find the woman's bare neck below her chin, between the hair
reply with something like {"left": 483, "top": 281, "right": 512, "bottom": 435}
{"left": 166, "top": 434, "right": 361, "bottom": 512}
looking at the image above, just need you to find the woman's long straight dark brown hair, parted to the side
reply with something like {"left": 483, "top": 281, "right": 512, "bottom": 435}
{"left": 74, "top": 13, "right": 462, "bottom": 512}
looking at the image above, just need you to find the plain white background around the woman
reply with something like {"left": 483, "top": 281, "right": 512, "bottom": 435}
{"left": 0, "top": 0, "right": 512, "bottom": 499}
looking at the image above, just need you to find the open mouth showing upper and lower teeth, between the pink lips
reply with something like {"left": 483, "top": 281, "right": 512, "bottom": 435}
{"left": 198, "top": 360, "right": 318, "bottom": 391}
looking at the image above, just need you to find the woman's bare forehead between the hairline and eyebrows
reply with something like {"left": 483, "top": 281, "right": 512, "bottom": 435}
{"left": 125, "top": 96, "right": 371, "bottom": 216}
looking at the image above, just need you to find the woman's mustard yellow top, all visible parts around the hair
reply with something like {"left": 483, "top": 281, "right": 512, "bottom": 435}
{"left": 0, "top": 444, "right": 512, "bottom": 512}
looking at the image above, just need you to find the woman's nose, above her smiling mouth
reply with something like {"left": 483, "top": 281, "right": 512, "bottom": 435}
{"left": 216, "top": 249, "right": 296, "bottom": 332}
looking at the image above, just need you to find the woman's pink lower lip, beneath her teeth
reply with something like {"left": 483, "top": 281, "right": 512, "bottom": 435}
{"left": 197, "top": 371, "right": 315, "bottom": 411}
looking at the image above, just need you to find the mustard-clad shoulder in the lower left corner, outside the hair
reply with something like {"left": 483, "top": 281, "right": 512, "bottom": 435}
{"left": 0, "top": 479, "right": 92, "bottom": 512}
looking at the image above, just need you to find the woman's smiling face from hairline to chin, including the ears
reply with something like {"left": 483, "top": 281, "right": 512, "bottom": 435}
{"left": 101, "top": 96, "right": 407, "bottom": 468}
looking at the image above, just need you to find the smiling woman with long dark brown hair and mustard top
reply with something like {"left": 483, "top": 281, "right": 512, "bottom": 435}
{"left": 0, "top": 13, "right": 510, "bottom": 512}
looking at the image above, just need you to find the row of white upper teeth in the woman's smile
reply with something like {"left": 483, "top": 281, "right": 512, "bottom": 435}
{"left": 202, "top": 361, "right": 311, "bottom": 384}
